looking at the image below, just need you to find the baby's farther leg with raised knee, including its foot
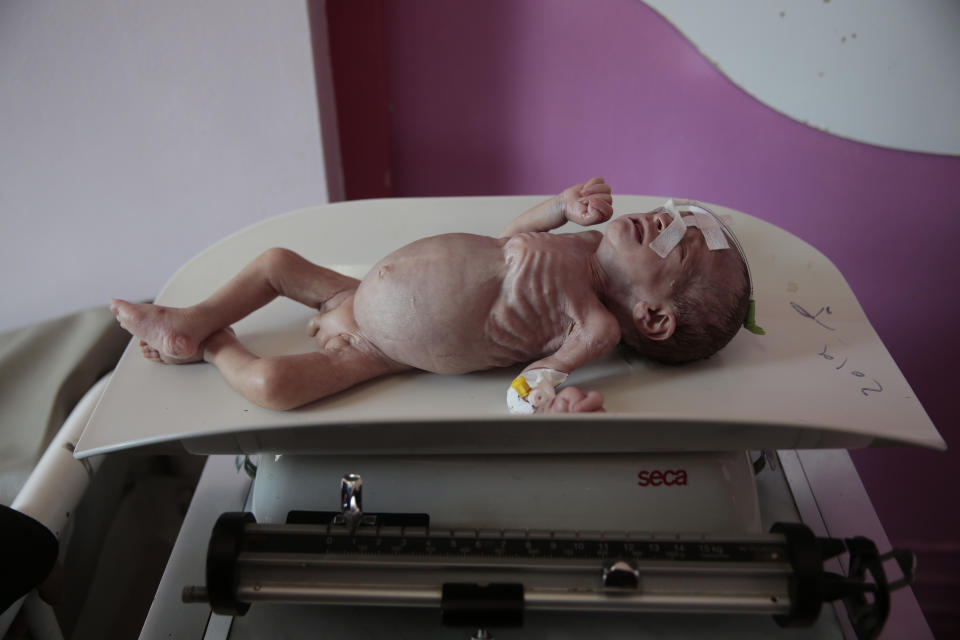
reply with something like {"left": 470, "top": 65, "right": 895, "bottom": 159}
{"left": 110, "top": 248, "right": 359, "bottom": 364}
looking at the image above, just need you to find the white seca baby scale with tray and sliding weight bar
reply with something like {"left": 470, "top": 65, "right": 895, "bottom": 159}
{"left": 76, "top": 196, "right": 945, "bottom": 638}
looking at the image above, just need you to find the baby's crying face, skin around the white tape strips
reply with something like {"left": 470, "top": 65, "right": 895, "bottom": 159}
{"left": 597, "top": 211, "right": 739, "bottom": 308}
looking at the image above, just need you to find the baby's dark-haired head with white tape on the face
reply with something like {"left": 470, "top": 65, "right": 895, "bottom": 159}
{"left": 597, "top": 203, "right": 750, "bottom": 364}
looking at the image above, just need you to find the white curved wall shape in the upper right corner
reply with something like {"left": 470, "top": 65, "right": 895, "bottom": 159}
{"left": 645, "top": 0, "right": 960, "bottom": 155}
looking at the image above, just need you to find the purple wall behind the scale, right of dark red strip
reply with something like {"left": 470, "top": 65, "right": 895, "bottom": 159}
{"left": 386, "top": 0, "right": 960, "bottom": 624}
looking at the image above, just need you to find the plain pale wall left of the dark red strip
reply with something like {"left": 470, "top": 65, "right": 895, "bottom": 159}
{"left": 0, "top": 0, "right": 336, "bottom": 331}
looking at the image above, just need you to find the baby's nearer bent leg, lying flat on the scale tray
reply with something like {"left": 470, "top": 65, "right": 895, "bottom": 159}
{"left": 204, "top": 330, "right": 410, "bottom": 411}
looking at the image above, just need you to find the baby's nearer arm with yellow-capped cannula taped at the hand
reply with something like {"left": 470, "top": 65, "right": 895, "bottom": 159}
{"left": 508, "top": 308, "right": 620, "bottom": 413}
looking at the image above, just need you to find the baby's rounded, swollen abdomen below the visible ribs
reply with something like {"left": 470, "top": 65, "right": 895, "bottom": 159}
{"left": 354, "top": 234, "right": 516, "bottom": 374}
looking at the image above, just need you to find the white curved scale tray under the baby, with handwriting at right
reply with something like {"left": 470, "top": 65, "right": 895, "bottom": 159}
{"left": 77, "top": 196, "right": 946, "bottom": 457}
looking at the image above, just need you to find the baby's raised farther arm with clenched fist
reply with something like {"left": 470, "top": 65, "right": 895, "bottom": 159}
{"left": 500, "top": 178, "right": 613, "bottom": 238}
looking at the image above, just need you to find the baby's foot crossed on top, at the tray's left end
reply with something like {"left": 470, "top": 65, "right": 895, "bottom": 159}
{"left": 110, "top": 299, "right": 206, "bottom": 364}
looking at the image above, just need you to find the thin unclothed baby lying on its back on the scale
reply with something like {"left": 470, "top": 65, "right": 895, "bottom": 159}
{"left": 110, "top": 178, "right": 750, "bottom": 413}
